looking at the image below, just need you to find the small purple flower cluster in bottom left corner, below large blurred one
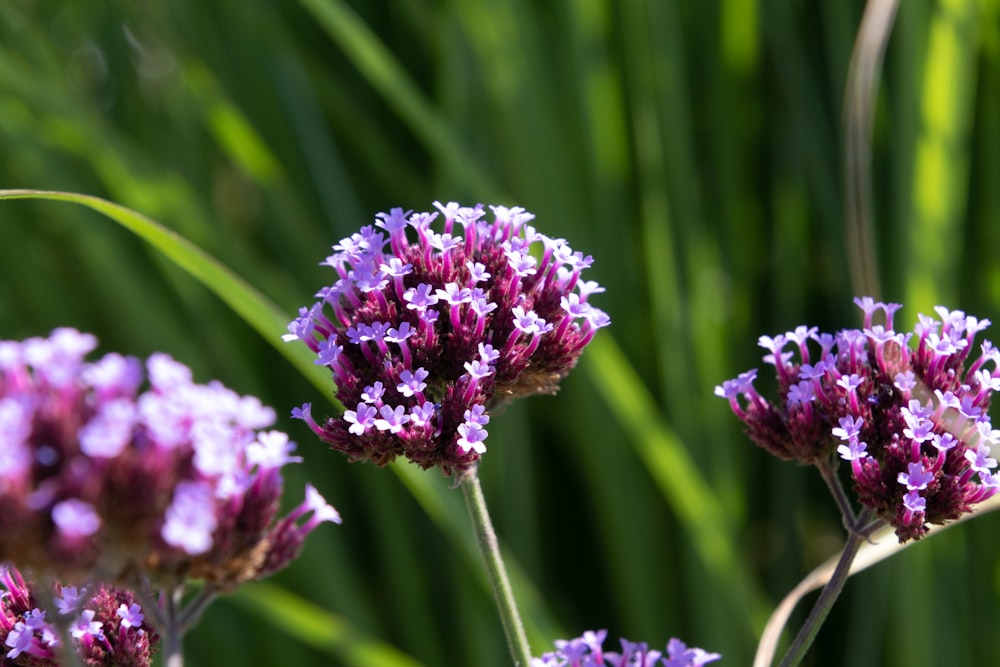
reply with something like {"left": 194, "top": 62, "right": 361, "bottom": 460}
{"left": 0, "top": 567, "right": 159, "bottom": 667}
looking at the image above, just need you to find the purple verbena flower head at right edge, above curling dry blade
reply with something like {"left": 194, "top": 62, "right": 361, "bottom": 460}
{"left": 715, "top": 297, "right": 1000, "bottom": 542}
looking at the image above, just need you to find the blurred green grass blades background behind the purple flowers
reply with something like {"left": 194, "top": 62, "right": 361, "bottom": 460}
{"left": 0, "top": 0, "right": 1000, "bottom": 667}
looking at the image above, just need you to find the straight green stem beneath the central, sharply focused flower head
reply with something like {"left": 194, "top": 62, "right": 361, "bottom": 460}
{"left": 460, "top": 468, "right": 531, "bottom": 667}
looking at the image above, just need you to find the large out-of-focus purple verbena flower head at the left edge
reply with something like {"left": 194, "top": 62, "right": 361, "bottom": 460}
{"left": 0, "top": 329, "right": 339, "bottom": 590}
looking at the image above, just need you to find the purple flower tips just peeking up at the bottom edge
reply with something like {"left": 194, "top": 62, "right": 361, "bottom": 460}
{"left": 531, "top": 630, "right": 722, "bottom": 667}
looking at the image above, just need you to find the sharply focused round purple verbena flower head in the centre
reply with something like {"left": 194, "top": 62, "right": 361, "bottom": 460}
{"left": 285, "top": 202, "right": 609, "bottom": 475}
